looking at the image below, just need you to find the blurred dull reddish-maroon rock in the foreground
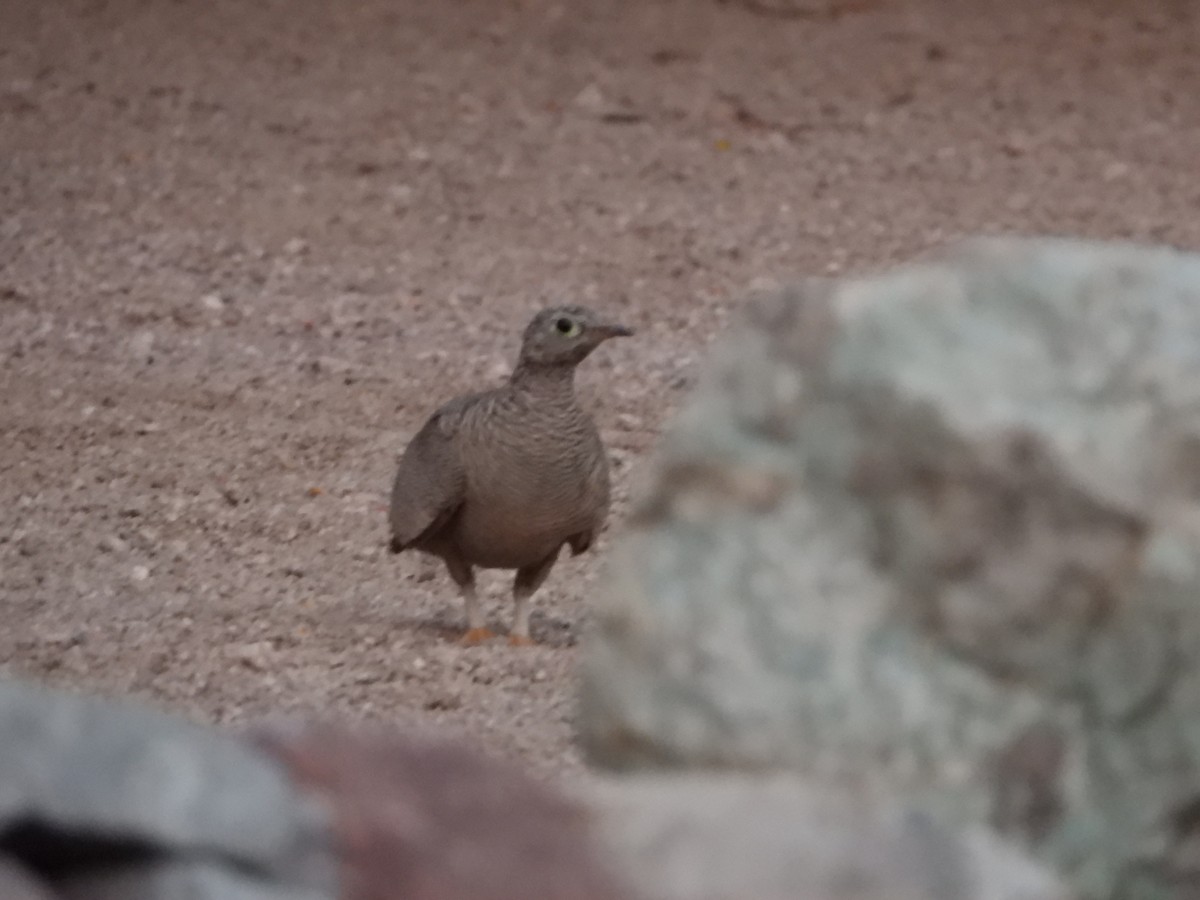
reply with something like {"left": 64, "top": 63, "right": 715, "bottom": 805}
{"left": 249, "top": 726, "right": 629, "bottom": 900}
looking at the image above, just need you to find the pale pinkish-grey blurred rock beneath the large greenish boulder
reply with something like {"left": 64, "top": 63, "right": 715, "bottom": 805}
{"left": 587, "top": 775, "right": 1069, "bottom": 900}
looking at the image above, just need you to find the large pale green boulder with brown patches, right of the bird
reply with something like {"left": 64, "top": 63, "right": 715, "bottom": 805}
{"left": 581, "top": 239, "right": 1200, "bottom": 898}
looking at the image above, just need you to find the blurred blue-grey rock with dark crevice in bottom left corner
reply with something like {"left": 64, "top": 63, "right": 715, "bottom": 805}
{"left": 0, "top": 682, "right": 336, "bottom": 898}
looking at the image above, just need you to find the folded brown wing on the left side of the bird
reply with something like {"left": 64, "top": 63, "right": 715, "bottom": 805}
{"left": 389, "top": 398, "right": 467, "bottom": 553}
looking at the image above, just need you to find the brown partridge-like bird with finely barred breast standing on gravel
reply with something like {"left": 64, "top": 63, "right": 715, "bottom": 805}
{"left": 389, "top": 305, "right": 634, "bottom": 646}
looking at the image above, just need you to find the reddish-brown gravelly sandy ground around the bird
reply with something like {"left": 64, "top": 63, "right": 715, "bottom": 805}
{"left": 0, "top": 0, "right": 1200, "bottom": 775}
